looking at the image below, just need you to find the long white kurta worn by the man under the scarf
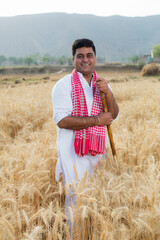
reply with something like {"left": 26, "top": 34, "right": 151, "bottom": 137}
{"left": 52, "top": 73, "right": 107, "bottom": 184}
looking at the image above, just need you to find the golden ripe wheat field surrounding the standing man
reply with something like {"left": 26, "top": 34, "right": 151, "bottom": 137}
{"left": 0, "top": 72, "right": 160, "bottom": 240}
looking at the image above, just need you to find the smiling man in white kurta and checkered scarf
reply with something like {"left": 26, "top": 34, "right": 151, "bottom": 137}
{"left": 52, "top": 39, "right": 119, "bottom": 218}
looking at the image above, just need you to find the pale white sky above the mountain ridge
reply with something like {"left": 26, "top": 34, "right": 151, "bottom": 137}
{"left": 0, "top": 0, "right": 160, "bottom": 17}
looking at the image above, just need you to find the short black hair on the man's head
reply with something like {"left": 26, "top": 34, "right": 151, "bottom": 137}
{"left": 72, "top": 38, "right": 96, "bottom": 57}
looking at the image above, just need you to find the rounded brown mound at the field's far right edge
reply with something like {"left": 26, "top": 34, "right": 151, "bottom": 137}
{"left": 141, "top": 63, "right": 160, "bottom": 76}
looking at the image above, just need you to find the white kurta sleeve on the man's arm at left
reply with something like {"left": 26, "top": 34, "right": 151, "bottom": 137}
{"left": 52, "top": 79, "right": 72, "bottom": 123}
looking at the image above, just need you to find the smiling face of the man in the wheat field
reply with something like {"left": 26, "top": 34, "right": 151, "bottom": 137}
{"left": 72, "top": 47, "right": 96, "bottom": 75}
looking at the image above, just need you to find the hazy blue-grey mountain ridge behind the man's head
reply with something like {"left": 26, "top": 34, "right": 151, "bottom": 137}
{"left": 0, "top": 13, "right": 160, "bottom": 61}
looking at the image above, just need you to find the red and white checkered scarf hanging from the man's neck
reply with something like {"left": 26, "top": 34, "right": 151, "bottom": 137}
{"left": 71, "top": 69, "right": 105, "bottom": 156}
